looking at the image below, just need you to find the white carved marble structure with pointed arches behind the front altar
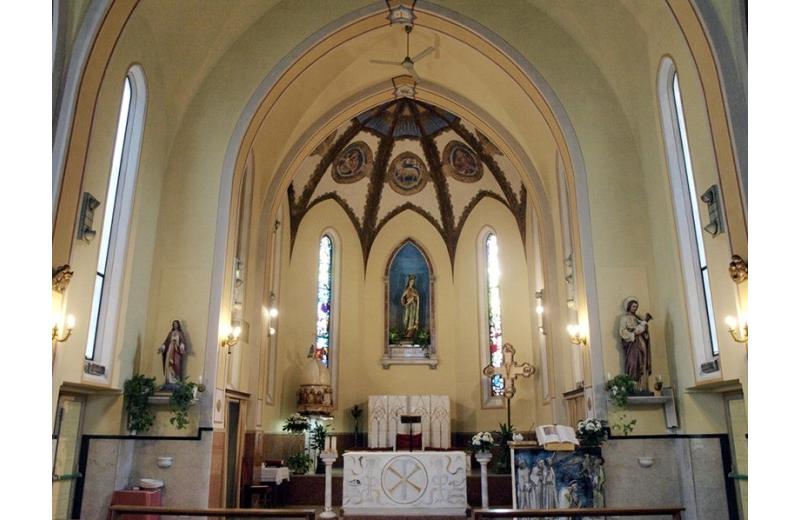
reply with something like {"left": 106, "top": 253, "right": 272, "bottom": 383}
{"left": 367, "top": 395, "right": 450, "bottom": 449}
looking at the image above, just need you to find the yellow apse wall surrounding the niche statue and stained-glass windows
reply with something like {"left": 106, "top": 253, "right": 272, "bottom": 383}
{"left": 264, "top": 199, "right": 536, "bottom": 431}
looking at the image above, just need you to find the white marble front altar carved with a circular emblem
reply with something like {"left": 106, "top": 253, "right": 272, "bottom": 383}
{"left": 342, "top": 451, "right": 467, "bottom": 517}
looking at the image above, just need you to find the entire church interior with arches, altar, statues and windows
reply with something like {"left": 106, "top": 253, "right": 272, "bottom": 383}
{"left": 51, "top": 0, "right": 748, "bottom": 520}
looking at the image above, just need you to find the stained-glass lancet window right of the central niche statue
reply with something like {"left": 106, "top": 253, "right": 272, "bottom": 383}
{"left": 478, "top": 228, "right": 505, "bottom": 408}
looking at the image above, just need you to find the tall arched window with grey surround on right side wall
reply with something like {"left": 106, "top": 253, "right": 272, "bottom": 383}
{"left": 658, "top": 58, "right": 719, "bottom": 370}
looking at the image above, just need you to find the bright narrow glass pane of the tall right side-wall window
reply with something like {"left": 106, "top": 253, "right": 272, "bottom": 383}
{"left": 672, "top": 73, "right": 719, "bottom": 356}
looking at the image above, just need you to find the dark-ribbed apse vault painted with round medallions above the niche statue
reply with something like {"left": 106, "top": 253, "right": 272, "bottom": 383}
{"left": 288, "top": 98, "right": 527, "bottom": 266}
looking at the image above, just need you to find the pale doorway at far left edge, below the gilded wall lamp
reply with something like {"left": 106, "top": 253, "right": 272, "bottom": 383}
{"left": 53, "top": 394, "right": 86, "bottom": 519}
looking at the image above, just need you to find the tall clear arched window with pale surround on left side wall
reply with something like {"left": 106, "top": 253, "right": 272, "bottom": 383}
{"left": 85, "top": 65, "right": 147, "bottom": 379}
